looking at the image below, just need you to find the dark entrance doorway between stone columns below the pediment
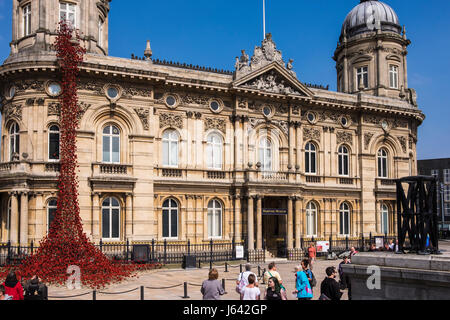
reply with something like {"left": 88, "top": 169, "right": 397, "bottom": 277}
{"left": 262, "top": 197, "right": 288, "bottom": 258}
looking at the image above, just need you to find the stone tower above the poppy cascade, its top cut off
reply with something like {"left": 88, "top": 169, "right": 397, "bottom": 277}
{"left": 10, "top": 0, "right": 111, "bottom": 58}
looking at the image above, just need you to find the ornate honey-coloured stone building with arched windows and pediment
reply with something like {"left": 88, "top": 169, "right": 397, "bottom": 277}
{"left": 0, "top": 0, "right": 425, "bottom": 253}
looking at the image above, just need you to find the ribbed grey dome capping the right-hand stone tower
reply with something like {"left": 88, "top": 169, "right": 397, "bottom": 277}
{"left": 341, "top": 0, "right": 402, "bottom": 37}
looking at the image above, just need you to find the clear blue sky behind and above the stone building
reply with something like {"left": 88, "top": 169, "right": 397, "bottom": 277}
{"left": 0, "top": 0, "right": 450, "bottom": 159}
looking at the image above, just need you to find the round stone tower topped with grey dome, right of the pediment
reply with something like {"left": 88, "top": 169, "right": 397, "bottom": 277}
{"left": 333, "top": 0, "right": 411, "bottom": 99}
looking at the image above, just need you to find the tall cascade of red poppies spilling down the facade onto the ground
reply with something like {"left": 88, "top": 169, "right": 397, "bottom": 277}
{"left": 12, "top": 22, "right": 137, "bottom": 288}
